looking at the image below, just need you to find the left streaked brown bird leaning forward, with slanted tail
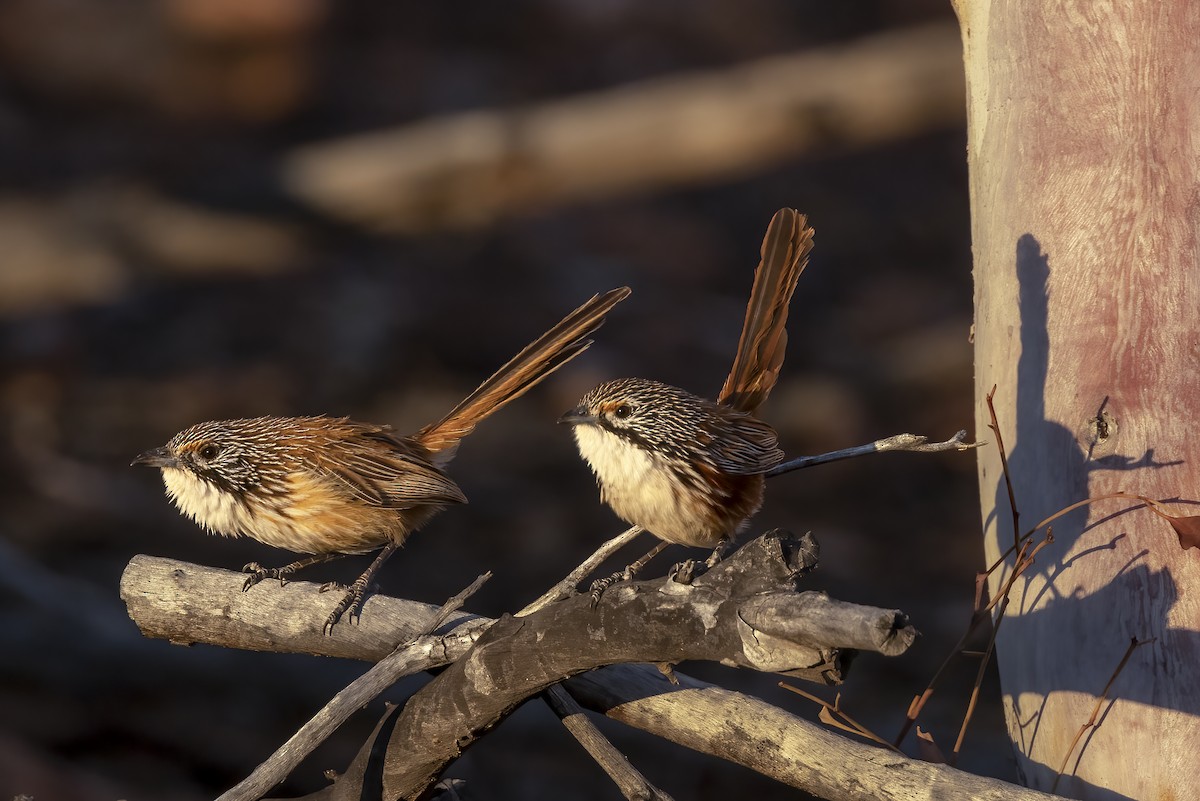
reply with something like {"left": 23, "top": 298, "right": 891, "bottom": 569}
{"left": 133, "top": 287, "right": 630, "bottom": 632}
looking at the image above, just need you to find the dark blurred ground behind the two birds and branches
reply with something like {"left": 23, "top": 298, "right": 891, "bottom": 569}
{"left": 0, "top": 0, "right": 1012, "bottom": 801}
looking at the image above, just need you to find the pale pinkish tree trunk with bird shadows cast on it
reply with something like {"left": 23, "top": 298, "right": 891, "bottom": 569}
{"left": 955, "top": 0, "right": 1200, "bottom": 800}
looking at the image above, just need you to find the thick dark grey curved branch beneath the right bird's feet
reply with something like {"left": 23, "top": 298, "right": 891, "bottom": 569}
{"left": 369, "top": 532, "right": 895, "bottom": 799}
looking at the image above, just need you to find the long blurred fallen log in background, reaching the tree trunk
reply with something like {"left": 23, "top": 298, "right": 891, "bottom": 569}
{"left": 282, "top": 24, "right": 965, "bottom": 234}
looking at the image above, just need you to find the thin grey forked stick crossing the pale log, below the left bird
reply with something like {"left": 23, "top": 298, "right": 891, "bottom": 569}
{"left": 217, "top": 571, "right": 492, "bottom": 801}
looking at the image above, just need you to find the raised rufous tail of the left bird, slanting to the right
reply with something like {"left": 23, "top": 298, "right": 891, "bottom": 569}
{"left": 416, "top": 287, "right": 630, "bottom": 464}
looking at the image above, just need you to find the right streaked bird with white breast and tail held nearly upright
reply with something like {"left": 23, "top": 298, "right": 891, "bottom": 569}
{"left": 559, "top": 209, "right": 812, "bottom": 577}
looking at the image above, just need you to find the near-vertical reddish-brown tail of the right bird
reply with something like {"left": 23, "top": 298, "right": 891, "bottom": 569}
{"left": 716, "top": 209, "right": 812, "bottom": 412}
